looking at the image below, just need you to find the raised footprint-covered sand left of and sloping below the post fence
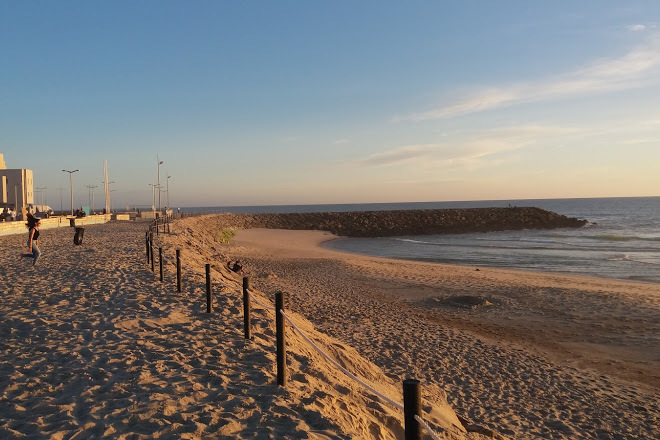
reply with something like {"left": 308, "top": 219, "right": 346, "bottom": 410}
{"left": 0, "top": 222, "right": 476, "bottom": 439}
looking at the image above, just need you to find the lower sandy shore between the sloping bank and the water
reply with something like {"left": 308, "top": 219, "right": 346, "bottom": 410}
{"left": 227, "top": 229, "right": 660, "bottom": 439}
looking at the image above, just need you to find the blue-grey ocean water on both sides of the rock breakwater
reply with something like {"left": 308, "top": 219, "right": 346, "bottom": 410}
{"left": 183, "top": 197, "right": 660, "bottom": 283}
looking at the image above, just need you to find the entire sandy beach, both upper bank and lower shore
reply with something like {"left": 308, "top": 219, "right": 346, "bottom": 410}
{"left": 0, "top": 217, "right": 660, "bottom": 439}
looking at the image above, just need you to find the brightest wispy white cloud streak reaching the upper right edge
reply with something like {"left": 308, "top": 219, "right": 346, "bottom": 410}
{"left": 395, "top": 40, "right": 660, "bottom": 121}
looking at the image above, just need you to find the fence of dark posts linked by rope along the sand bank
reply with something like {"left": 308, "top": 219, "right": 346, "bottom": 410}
{"left": 146, "top": 215, "right": 454, "bottom": 440}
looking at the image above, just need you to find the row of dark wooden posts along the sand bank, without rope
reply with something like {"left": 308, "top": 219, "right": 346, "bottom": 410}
{"left": 146, "top": 225, "right": 422, "bottom": 440}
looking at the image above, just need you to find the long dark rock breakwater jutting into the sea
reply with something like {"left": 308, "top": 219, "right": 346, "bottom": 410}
{"left": 197, "top": 207, "right": 587, "bottom": 237}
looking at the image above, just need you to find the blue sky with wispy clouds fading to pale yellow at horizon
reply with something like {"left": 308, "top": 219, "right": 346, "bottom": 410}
{"left": 0, "top": 0, "right": 660, "bottom": 209}
